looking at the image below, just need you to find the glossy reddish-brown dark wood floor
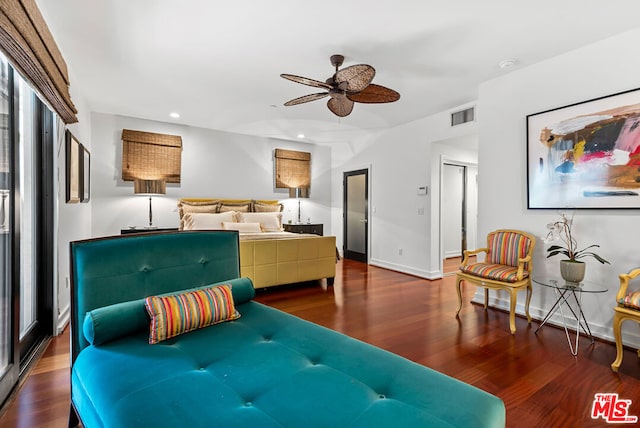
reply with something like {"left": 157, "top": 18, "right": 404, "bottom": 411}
{"left": 0, "top": 260, "right": 640, "bottom": 428}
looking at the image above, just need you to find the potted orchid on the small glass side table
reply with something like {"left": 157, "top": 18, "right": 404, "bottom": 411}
{"left": 544, "top": 213, "right": 610, "bottom": 283}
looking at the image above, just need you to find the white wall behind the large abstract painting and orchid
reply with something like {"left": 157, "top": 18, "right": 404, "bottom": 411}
{"left": 476, "top": 26, "right": 640, "bottom": 347}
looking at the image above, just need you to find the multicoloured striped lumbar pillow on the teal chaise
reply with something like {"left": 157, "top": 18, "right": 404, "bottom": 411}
{"left": 144, "top": 285, "right": 240, "bottom": 345}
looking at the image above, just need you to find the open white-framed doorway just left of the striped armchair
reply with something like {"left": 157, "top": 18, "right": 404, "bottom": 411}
{"left": 440, "top": 160, "right": 478, "bottom": 275}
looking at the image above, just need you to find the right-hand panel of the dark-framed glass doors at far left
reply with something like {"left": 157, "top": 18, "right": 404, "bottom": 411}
{"left": 18, "top": 93, "right": 54, "bottom": 365}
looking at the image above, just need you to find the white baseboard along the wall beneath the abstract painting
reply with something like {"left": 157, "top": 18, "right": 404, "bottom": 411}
{"left": 471, "top": 288, "right": 640, "bottom": 349}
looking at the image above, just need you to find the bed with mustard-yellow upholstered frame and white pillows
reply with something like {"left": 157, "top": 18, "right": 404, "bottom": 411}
{"left": 178, "top": 198, "right": 336, "bottom": 288}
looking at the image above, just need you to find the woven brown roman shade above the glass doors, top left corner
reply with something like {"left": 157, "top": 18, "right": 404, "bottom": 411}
{"left": 0, "top": 0, "right": 78, "bottom": 124}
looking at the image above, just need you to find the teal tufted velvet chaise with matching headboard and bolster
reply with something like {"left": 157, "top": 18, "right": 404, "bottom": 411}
{"left": 70, "top": 231, "right": 505, "bottom": 428}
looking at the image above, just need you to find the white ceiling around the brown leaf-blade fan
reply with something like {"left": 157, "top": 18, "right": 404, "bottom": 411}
{"left": 36, "top": 0, "right": 640, "bottom": 143}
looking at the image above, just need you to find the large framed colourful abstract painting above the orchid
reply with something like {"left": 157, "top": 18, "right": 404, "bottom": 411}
{"left": 527, "top": 89, "right": 640, "bottom": 209}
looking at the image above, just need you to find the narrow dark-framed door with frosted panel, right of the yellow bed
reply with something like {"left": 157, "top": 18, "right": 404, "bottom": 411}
{"left": 343, "top": 169, "right": 369, "bottom": 263}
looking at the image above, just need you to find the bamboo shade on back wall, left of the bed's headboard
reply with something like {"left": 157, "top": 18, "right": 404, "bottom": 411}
{"left": 122, "top": 129, "right": 182, "bottom": 183}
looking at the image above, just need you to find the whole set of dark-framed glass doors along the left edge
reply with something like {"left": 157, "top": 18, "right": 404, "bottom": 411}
{"left": 0, "top": 56, "right": 55, "bottom": 404}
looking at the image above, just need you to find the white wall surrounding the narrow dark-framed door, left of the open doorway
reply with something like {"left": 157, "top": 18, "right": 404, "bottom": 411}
{"left": 332, "top": 103, "right": 476, "bottom": 278}
